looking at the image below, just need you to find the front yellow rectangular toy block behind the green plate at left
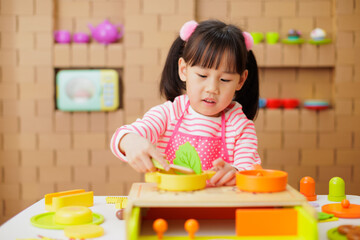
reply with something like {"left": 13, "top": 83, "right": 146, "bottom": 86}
{"left": 48, "top": 191, "right": 94, "bottom": 211}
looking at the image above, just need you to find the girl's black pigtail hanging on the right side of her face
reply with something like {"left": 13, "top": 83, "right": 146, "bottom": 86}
{"left": 234, "top": 50, "right": 259, "bottom": 120}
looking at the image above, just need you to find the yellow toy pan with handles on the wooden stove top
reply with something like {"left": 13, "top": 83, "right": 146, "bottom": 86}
{"left": 145, "top": 171, "right": 216, "bottom": 191}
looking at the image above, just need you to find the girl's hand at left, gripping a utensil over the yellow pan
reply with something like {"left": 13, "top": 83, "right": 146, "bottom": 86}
{"left": 119, "top": 133, "right": 170, "bottom": 173}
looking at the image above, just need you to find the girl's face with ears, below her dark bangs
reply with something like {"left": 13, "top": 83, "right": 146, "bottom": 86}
{"left": 178, "top": 57, "right": 248, "bottom": 117}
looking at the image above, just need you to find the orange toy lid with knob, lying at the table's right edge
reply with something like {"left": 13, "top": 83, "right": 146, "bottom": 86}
{"left": 321, "top": 199, "right": 360, "bottom": 218}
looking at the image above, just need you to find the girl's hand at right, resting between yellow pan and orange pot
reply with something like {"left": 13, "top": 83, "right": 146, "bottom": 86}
{"left": 210, "top": 158, "right": 237, "bottom": 187}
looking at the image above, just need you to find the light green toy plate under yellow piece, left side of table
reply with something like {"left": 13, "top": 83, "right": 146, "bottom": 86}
{"left": 30, "top": 212, "right": 104, "bottom": 229}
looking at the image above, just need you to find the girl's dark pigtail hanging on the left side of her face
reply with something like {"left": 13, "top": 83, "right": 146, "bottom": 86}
{"left": 160, "top": 37, "right": 186, "bottom": 101}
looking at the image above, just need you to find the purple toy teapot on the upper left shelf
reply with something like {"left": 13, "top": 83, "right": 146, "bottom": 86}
{"left": 88, "top": 20, "right": 124, "bottom": 45}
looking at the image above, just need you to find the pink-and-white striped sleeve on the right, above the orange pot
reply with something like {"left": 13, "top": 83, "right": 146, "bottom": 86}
{"left": 234, "top": 120, "right": 261, "bottom": 171}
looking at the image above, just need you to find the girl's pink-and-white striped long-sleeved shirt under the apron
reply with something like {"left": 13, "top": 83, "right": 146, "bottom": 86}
{"left": 110, "top": 95, "right": 261, "bottom": 170}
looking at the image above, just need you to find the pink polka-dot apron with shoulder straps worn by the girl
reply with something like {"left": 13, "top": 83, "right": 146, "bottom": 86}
{"left": 165, "top": 102, "right": 229, "bottom": 170}
